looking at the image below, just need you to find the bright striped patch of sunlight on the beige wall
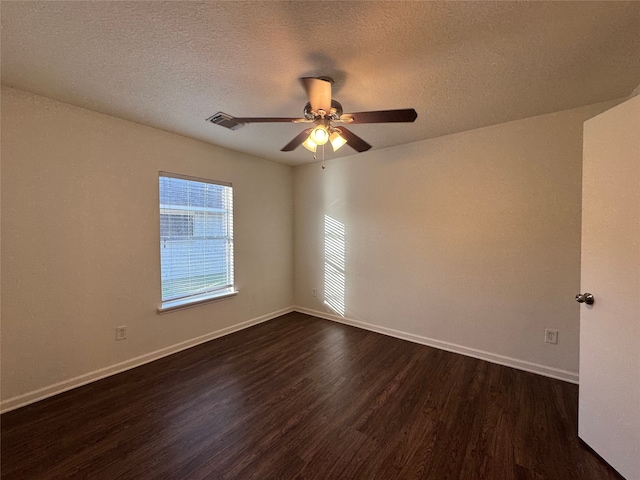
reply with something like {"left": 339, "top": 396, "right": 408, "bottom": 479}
{"left": 324, "top": 215, "right": 345, "bottom": 317}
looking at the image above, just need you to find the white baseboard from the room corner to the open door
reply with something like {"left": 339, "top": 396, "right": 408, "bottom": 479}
{"left": 293, "top": 306, "right": 579, "bottom": 384}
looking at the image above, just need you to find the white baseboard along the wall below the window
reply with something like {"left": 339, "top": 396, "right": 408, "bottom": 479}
{"left": 0, "top": 307, "right": 294, "bottom": 413}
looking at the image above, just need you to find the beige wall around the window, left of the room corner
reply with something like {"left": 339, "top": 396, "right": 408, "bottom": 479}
{"left": 1, "top": 88, "right": 293, "bottom": 408}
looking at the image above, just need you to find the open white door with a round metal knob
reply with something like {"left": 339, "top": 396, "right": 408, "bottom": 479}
{"left": 578, "top": 96, "right": 640, "bottom": 480}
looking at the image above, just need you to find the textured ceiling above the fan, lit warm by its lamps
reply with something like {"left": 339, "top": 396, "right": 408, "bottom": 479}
{"left": 1, "top": 1, "right": 640, "bottom": 165}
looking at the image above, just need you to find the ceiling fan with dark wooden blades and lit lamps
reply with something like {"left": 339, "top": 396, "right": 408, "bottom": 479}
{"left": 207, "top": 77, "right": 418, "bottom": 153}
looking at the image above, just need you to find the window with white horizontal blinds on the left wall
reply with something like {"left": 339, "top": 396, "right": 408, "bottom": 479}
{"left": 160, "top": 172, "right": 236, "bottom": 310}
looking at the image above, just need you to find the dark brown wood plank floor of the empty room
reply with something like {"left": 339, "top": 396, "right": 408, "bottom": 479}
{"left": 1, "top": 313, "right": 621, "bottom": 480}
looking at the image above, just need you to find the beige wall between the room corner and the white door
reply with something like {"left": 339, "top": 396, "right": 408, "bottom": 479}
{"left": 294, "top": 99, "right": 613, "bottom": 381}
